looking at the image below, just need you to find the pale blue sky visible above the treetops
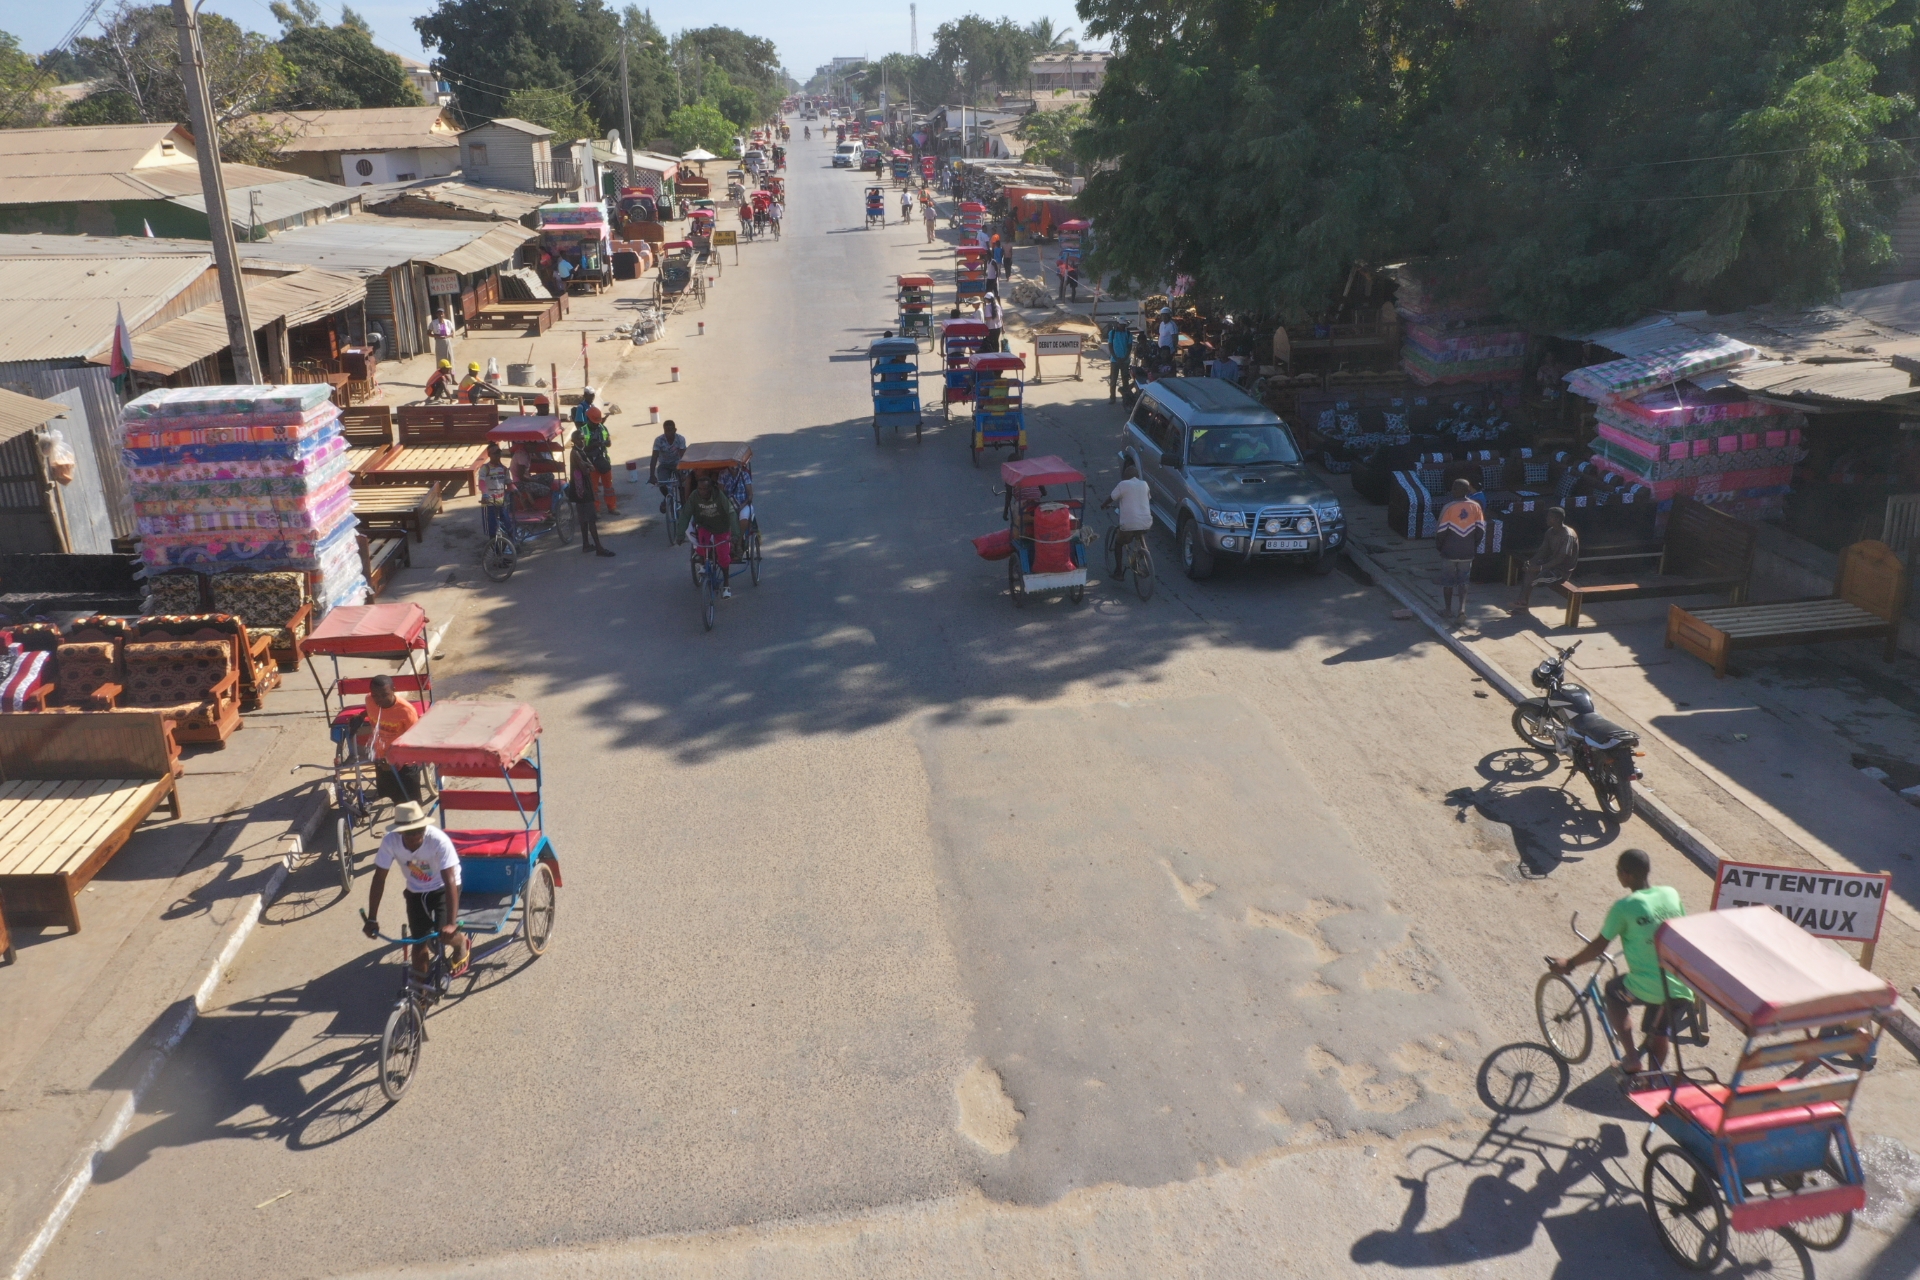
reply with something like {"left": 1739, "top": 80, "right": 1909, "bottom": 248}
{"left": 11, "top": 0, "right": 1085, "bottom": 83}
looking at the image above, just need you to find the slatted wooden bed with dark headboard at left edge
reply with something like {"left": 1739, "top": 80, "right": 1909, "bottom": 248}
{"left": 0, "top": 710, "right": 180, "bottom": 942}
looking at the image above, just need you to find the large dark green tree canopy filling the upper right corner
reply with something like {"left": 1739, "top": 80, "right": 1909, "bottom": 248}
{"left": 1077, "top": 0, "right": 1912, "bottom": 328}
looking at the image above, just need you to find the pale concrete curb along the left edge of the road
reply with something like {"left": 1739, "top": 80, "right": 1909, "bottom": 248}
{"left": 6, "top": 802, "right": 326, "bottom": 1280}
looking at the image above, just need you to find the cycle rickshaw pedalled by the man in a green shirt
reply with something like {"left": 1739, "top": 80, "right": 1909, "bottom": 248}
{"left": 1536, "top": 906, "right": 1897, "bottom": 1270}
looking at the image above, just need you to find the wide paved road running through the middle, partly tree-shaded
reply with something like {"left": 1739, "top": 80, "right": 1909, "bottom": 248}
{"left": 44, "top": 124, "right": 1920, "bottom": 1278}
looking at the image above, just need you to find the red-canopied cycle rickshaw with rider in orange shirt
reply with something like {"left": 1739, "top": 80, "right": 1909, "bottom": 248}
{"left": 301, "top": 601, "right": 434, "bottom": 892}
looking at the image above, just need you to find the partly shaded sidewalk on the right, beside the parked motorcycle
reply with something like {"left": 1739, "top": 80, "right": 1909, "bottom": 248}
{"left": 1325, "top": 476, "right": 1920, "bottom": 1000}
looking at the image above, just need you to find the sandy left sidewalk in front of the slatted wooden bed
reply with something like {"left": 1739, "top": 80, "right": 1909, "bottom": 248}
{"left": 0, "top": 672, "right": 340, "bottom": 1274}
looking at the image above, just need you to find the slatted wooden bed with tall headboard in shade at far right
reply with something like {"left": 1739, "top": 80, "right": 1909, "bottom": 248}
{"left": 1667, "top": 541, "right": 1907, "bottom": 677}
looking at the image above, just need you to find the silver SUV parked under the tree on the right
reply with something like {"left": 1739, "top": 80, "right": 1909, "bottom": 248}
{"left": 1121, "top": 378, "right": 1346, "bottom": 578}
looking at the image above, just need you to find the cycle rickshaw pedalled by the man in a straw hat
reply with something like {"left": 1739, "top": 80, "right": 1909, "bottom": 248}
{"left": 360, "top": 702, "right": 561, "bottom": 1102}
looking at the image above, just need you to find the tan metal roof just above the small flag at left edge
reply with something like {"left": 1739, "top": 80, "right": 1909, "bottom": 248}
{"left": 0, "top": 253, "right": 213, "bottom": 361}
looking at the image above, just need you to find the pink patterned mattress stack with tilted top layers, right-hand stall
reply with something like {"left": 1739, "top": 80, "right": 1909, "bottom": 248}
{"left": 1567, "top": 334, "right": 1807, "bottom": 520}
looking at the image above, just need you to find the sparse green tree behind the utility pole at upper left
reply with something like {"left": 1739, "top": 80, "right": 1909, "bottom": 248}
{"left": 65, "top": 0, "right": 286, "bottom": 126}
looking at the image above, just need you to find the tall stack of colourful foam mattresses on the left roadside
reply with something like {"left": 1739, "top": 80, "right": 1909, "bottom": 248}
{"left": 121, "top": 384, "right": 367, "bottom": 610}
